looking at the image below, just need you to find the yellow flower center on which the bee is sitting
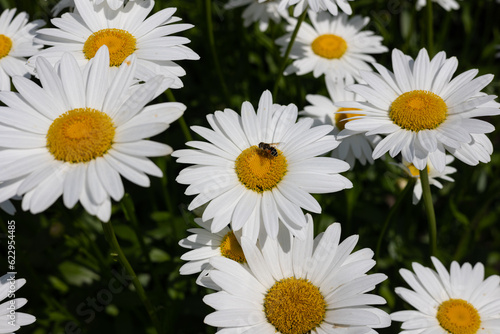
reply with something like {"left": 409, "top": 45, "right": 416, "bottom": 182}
{"left": 235, "top": 146, "right": 288, "bottom": 193}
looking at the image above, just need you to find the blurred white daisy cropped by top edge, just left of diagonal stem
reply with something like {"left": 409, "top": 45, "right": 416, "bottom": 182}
{"left": 224, "top": 0, "right": 289, "bottom": 31}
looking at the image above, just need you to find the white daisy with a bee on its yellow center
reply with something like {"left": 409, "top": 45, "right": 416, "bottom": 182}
{"left": 172, "top": 91, "right": 352, "bottom": 241}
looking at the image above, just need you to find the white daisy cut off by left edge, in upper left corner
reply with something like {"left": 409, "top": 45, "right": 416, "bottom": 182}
{"left": 0, "top": 8, "right": 45, "bottom": 91}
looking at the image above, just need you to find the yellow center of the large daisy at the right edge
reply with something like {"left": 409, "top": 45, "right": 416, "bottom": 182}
{"left": 389, "top": 90, "right": 448, "bottom": 132}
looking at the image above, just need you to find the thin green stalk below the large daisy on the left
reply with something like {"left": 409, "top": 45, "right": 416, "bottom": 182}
{"left": 102, "top": 222, "right": 158, "bottom": 334}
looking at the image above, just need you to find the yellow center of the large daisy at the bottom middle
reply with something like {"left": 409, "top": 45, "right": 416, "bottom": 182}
{"left": 264, "top": 277, "right": 326, "bottom": 334}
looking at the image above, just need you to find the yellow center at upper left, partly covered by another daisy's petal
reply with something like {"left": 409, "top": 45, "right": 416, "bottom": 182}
{"left": 83, "top": 28, "right": 136, "bottom": 66}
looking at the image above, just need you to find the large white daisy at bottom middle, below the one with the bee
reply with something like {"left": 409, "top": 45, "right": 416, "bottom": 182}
{"left": 203, "top": 215, "right": 391, "bottom": 334}
